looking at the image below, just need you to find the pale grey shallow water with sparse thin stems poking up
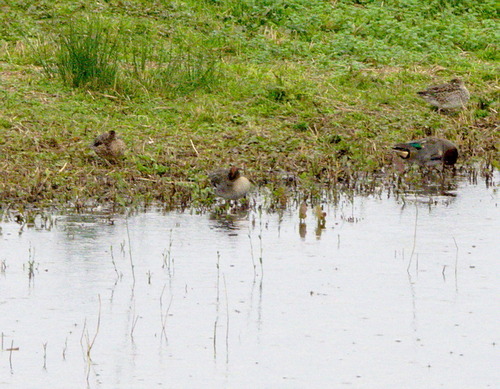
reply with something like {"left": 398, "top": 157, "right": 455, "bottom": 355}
{"left": 0, "top": 173, "right": 500, "bottom": 389}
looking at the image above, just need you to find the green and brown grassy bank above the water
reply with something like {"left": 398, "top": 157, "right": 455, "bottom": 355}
{"left": 0, "top": 0, "right": 500, "bottom": 206}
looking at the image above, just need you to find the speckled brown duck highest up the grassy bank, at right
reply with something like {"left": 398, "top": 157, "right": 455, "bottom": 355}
{"left": 417, "top": 78, "right": 470, "bottom": 110}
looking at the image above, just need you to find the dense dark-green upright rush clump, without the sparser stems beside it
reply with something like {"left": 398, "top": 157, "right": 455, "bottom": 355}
{"left": 56, "top": 19, "right": 119, "bottom": 90}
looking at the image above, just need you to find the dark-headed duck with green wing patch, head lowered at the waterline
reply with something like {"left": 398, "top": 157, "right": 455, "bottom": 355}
{"left": 393, "top": 138, "right": 458, "bottom": 166}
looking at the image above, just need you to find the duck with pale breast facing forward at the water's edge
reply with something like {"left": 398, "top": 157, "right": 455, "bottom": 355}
{"left": 208, "top": 166, "right": 252, "bottom": 200}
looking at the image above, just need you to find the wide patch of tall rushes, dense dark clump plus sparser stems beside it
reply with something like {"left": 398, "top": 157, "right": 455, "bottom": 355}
{"left": 43, "top": 19, "right": 221, "bottom": 97}
